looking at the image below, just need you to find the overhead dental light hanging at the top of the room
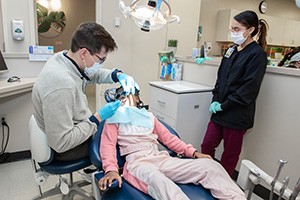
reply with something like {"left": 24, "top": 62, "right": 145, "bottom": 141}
{"left": 119, "top": 0, "right": 180, "bottom": 32}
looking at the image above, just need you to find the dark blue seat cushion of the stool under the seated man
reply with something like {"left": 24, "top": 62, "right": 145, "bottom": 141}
{"left": 40, "top": 157, "right": 92, "bottom": 174}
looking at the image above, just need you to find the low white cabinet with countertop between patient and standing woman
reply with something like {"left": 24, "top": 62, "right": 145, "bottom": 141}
{"left": 149, "top": 81, "right": 212, "bottom": 150}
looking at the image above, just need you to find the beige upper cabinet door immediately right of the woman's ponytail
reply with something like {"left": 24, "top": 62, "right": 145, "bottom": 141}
{"left": 263, "top": 15, "right": 285, "bottom": 45}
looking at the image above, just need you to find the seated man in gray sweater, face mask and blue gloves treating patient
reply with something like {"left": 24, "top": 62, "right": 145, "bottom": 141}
{"left": 32, "top": 22, "right": 138, "bottom": 161}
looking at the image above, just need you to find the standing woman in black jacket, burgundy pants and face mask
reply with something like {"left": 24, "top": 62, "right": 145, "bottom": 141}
{"left": 201, "top": 10, "right": 267, "bottom": 176}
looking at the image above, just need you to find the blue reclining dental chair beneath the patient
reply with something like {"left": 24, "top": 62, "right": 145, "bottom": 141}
{"left": 90, "top": 121, "right": 215, "bottom": 200}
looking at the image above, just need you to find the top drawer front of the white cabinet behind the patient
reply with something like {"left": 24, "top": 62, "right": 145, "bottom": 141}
{"left": 150, "top": 87, "right": 178, "bottom": 118}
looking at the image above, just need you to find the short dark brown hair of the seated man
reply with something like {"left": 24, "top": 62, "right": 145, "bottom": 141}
{"left": 71, "top": 22, "right": 117, "bottom": 54}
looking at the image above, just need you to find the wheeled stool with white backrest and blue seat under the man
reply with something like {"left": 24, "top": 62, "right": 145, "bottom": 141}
{"left": 29, "top": 115, "right": 95, "bottom": 200}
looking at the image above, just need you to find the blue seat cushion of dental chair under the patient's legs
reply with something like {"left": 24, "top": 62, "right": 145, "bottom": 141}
{"left": 95, "top": 172, "right": 215, "bottom": 200}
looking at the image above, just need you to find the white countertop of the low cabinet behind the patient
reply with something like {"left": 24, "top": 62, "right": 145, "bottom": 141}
{"left": 149, "top": 81, "right": 213, "bottom": 94}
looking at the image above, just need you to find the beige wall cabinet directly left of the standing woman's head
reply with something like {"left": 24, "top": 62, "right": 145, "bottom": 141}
{"left": 216, "top": 9, "right": 241, "bottom": 42}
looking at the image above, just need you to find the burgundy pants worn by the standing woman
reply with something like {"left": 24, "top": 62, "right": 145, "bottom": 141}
{"left": 201, "top": 121, "right": 247, "bottom": 176}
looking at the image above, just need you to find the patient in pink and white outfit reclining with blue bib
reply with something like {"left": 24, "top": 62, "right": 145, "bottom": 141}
{"left": 99, "top": 88, "right": 246, "bottom": 200}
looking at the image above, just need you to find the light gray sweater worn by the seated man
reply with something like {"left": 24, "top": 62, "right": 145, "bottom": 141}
{"left": 32, "top": 52, "right": 114, "bottom": 153}
